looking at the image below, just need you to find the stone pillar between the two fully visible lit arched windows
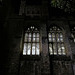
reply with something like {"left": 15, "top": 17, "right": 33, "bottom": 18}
{"left": 41, "top": 24, "right": 50, "bottom": 75}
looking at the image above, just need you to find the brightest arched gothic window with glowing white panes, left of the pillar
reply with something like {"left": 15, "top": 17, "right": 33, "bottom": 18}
{"left": 23, "top": 26, "right": 40, "bottom": 55}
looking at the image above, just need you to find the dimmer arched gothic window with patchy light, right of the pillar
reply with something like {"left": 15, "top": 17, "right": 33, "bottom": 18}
{"left": 48, "top": 26, "right": 66, "bottom": 55}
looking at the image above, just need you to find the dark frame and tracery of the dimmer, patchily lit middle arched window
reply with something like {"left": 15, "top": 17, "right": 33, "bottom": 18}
{"left": 48, "top": 25, "right": 66, "bottom": 56}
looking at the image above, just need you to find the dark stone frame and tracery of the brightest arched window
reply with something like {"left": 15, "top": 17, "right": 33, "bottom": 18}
{"left": 22, "top": 26, "right": 41, "bottom": 57}
